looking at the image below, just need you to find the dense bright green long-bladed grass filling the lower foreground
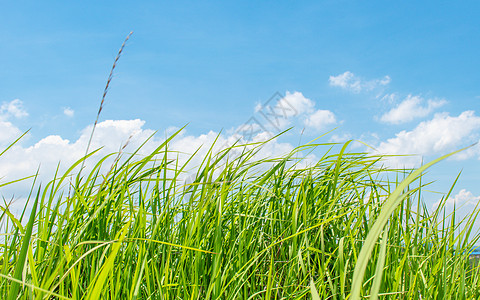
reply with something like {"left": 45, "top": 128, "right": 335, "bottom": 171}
{"left": 0, "top": 132, "right": 480, "bottom": 299}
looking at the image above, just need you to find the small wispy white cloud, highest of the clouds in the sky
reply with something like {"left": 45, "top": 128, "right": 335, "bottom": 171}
{"left": 328, "top": 71, "right": 391, "bottom": 93}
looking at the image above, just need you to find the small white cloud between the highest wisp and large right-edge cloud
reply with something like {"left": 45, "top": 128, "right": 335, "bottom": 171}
{"left": 380, "top": 95, "right": 447, "bottom": 124}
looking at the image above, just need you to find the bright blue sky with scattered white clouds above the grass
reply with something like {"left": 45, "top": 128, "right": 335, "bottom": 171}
{"left": 0, "top": 1, "right": 480, "bottom": 227}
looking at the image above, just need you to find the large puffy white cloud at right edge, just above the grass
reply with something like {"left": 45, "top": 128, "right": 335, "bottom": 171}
{"left": 377, "top": 111, "right": 480, "bottom": 167}
